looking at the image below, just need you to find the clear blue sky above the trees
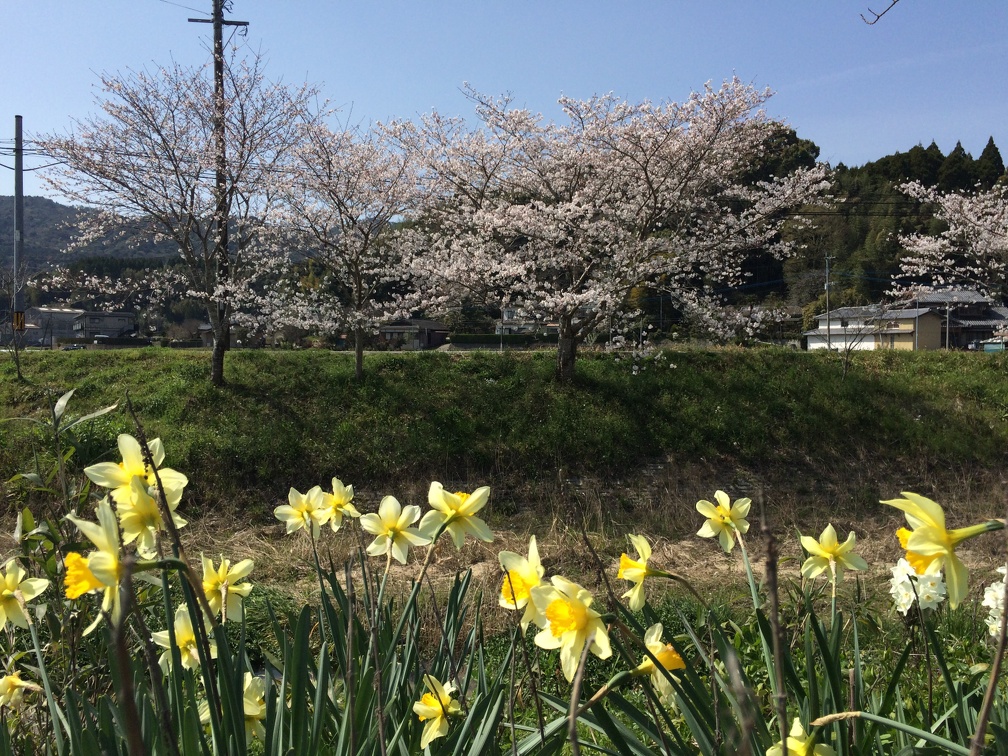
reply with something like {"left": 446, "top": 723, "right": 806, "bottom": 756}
{"left": 0, "top": 0, "right": 1008, "bottom": 195}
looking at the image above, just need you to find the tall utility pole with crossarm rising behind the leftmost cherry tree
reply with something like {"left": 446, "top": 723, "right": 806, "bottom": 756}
{"left": 188, "top": 0, "right": 249, "bottom": 385}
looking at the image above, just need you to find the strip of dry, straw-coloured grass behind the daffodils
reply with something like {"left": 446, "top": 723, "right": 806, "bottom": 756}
{"left": 177, "top": 465, "right": 1005, "bottom": 645}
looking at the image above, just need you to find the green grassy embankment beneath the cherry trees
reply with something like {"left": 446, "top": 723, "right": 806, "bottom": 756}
{"left": 0, "top": 348, "right": 1008, "bottom": 514}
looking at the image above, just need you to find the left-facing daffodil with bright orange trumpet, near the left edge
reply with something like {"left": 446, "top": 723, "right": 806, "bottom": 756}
{"left": 64, "top": 499, "right": 122, "bottom": 635}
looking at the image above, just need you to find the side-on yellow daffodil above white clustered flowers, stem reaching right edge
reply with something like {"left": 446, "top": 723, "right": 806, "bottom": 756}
{"left": 882, "top": 491, "right": 1004, "bottom": 609}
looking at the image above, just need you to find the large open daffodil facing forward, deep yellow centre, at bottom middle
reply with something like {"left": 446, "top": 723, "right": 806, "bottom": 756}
{"left": 531, "top": 575, "right": 612, "bottom": 682}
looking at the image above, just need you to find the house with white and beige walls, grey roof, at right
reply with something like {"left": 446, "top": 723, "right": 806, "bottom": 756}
{"left": 802, "top": 304, "right": 943, "bottom": 351}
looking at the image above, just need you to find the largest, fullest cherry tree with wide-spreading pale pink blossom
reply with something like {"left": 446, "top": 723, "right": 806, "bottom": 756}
{"left": 390, "top": 80, "right": 827, "bottom": 381}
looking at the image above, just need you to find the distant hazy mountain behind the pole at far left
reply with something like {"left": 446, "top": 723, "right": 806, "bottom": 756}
{"left": 0, "top": 197, "right": 175, "bottom": 273}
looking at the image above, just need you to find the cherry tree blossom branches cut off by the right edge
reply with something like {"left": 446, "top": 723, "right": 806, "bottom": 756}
{"left": 894, "top": 183, "right": 1008, "bottom": 302}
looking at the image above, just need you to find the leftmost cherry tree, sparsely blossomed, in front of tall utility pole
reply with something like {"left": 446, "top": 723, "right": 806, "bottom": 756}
{"left": 36, "top": 48, "right": 318, "bottom": 385}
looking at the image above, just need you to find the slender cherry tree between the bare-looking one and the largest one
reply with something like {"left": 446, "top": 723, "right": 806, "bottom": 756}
{"left": 277, "top": 123, "right": 419, "bottom": 379}
